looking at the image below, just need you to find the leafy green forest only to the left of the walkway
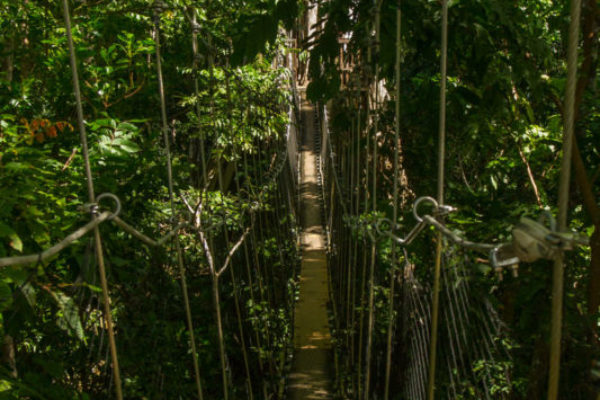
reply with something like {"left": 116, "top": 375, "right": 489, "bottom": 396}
{"left": 0, "top": 1, "right": 296, "bottom": 399}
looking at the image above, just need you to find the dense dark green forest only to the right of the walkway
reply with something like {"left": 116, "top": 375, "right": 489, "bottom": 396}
{"left": 309, "top": 0, "right": 600, "bottom": 399}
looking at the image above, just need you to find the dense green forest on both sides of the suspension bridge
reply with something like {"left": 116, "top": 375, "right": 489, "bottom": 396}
{"left": 0, "top": 0, "right": 600, "bottom": 399}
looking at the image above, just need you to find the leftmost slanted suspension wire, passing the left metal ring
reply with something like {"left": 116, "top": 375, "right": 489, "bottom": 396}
{"left": 63, "top": 0, "right": 123, "bottom": 400}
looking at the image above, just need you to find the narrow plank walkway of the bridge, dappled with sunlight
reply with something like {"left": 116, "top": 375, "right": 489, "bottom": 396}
{"left": 288, "top": 98, "right": 332, "bottom": 400}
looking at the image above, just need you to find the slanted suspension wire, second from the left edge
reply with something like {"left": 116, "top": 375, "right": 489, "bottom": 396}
{"left": 154, "top": 13, "right": 204, "bottom": 400}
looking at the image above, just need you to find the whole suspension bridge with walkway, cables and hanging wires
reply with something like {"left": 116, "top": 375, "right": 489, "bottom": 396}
{"left": 0, "top": 0, "right": 588, "bottom": 400}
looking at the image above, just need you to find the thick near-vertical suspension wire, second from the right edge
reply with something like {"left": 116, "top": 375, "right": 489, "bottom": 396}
{"left": 427, "top": 0, "right": 448, "bottom": 400}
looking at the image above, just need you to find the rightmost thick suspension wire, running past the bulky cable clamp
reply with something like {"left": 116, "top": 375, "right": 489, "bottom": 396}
{"left": 548, "top": 0, "right": 580, "bottom": 400}
